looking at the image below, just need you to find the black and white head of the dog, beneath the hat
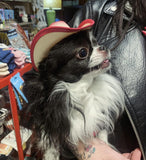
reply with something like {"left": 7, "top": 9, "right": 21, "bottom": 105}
{"left": 39, "top": 31, "right": 110, "bottom": 82}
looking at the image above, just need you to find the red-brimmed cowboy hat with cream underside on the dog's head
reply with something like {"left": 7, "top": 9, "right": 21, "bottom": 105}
{"left": 30, "top": 19, "right": 94, "bottom": 70}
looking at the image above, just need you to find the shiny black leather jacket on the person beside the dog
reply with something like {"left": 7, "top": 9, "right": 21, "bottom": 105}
{"left": 69, "top": 0, "right": 146, "bottom": 160}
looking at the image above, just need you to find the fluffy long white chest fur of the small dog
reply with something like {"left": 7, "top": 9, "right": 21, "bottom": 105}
{"left": 54, "top": 72, "right": 124, "bottom": 144}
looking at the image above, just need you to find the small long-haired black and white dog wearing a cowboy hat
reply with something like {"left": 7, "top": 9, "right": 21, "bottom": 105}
{"left": 24, "top": 25, "right": 125, "bottom": 160}
